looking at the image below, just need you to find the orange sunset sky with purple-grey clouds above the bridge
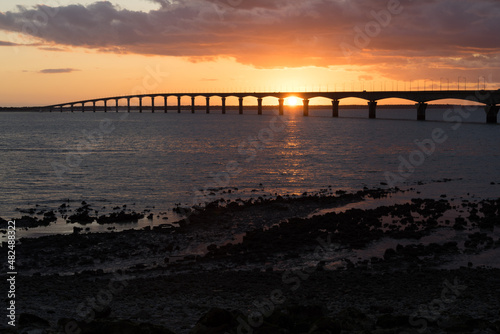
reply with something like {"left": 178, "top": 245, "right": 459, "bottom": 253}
{"left": 0, "top": 0, "right": 500, "bottom": 106}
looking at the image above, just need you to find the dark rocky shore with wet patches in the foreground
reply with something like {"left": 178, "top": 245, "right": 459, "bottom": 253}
{"left": 0, "top": 189, "right": 500, "bottom": 334}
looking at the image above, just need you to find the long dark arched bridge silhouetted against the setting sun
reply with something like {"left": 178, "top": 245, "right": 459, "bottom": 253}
{"left": 39, "top": 89, "right": 500, "bottom": 124}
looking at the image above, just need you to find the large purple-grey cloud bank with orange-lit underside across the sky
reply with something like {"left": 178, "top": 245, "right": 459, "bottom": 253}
{"left": 0, "top": 0, "right": 500, "bottom": 74}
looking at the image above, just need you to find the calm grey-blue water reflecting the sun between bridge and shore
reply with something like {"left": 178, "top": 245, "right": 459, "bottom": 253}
{"left": 0, "top": 108, "right": 500, "bottom": 227}
